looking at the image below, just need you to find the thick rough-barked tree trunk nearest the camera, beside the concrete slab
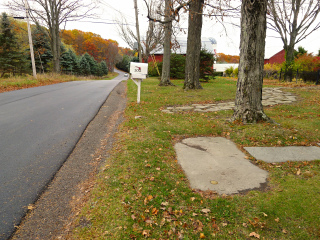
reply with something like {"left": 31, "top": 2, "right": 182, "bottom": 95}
{"left": 231, "top": 0, "right": 271, "bottom": 123}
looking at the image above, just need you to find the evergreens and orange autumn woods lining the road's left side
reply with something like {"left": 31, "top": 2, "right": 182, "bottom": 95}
{"left": 0, "top": 13, "right": 129, "bottom": 77}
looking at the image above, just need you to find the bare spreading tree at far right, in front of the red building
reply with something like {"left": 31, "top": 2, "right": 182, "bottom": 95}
{"left": 268, "top": 0, "right": 320, "bottom": 80}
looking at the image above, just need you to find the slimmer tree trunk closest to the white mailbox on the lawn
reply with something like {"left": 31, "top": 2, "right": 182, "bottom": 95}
{"left": 159, "top": 0, "right": 174, "bottom": 86}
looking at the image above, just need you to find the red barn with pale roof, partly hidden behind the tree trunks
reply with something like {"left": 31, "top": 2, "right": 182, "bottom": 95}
{"left": 148, "top": 37, "right": 217, "bottom": 62}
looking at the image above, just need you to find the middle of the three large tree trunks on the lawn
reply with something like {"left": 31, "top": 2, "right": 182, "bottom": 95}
{"left": 183, "top": 0, "right": 204, "bottom": 90}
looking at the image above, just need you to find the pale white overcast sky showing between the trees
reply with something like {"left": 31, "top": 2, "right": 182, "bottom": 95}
{"left": 0, "top": 0, "right": 320, "bottom": 58}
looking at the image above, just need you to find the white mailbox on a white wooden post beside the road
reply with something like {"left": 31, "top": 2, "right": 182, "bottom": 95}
{"left": 130, "top": 62, "right": 148, "bottom": 103}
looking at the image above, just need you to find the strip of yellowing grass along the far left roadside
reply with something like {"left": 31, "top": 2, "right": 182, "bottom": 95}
{"left": 0, "top": 72, "right": 118, "bottom": 93}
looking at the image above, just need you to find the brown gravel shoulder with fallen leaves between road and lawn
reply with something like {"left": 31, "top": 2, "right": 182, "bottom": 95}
{"left": 10, "top": 81, "right": 127, "bottom": 240}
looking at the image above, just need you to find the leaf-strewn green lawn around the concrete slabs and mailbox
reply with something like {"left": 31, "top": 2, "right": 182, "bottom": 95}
{"left": 70, "top": 78, "right": 320, "bottom": 239}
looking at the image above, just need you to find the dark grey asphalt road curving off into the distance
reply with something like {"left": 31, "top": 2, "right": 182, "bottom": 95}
{"left": 0, "top": 73, "right": 124, "bottom": 240}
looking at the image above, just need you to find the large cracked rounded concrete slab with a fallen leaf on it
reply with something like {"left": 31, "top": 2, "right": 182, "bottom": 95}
{"left": 175, "top": 137, "right": 268, "bottom": 195}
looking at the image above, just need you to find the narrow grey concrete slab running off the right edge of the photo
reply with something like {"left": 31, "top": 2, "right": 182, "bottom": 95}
{"left": 244, "top": 146, "right": 320, "bottom": 163}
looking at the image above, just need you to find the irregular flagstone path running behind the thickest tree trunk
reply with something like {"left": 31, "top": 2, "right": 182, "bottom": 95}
{"left": 162, "top": 88, "right": 296, "bottom": 113}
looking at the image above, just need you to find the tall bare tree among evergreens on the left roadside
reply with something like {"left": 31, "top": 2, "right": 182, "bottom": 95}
{"left": 9, "top": 0, "right": 95, "bottom": 72}
